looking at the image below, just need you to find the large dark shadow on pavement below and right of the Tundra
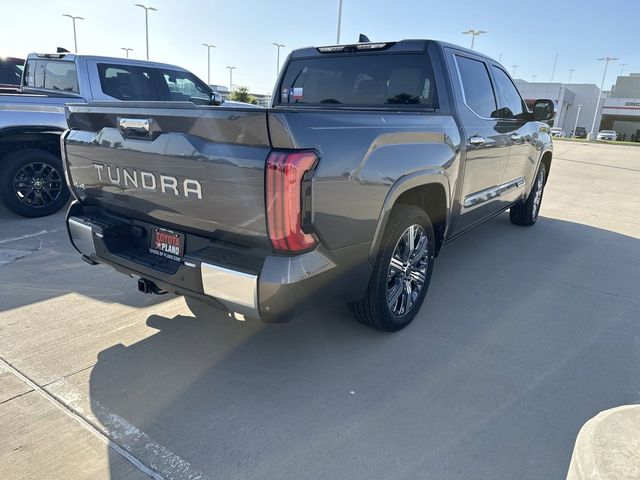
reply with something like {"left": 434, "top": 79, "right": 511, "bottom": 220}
{"left": 89, "top": 215, "right": 640, "bottom": 479}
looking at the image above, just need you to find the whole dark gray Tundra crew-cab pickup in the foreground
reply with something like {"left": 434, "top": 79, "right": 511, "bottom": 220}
{"left": 62, "top": 40, "right": 554, "bottom": 331}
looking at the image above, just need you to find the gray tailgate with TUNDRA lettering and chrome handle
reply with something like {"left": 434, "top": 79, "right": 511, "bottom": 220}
{"left": 64, "top": 102, "right": 270, "bottom": 239}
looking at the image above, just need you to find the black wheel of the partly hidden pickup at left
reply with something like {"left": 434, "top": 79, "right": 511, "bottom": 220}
{"left": 0, "top": 148, "right": 69, "bottom": 217}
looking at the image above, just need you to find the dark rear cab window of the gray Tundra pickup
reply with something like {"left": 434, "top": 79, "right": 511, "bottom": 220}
{"left": 278, "top": 53, "right": 438, "bottom": 108}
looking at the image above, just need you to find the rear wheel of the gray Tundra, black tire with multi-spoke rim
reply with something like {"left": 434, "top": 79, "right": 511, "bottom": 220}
{"left": 349, "top": 204, "right": 435, "bottom": 332}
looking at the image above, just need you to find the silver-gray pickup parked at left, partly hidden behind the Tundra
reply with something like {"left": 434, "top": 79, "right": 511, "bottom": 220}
{"left": 0, "top": 52, "right": 222, "bottom": 217}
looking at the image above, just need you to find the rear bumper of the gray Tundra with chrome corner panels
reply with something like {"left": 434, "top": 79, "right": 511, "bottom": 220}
{"left": 67, "top": 202, "right": 370, "bottom": 323}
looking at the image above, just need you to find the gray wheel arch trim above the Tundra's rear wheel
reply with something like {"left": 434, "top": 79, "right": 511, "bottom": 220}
{"left": 369, "top": 170, "right": 451, "bottom": 264}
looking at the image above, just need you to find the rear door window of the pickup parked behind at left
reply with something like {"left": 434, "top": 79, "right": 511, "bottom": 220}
{"left": 98, "top": 63, "right": 159, "bottom": 101}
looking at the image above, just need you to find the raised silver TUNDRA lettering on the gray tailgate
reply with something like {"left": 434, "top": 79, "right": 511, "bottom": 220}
{"left": 93, "top": 163, "right": 202, "bottom": 200}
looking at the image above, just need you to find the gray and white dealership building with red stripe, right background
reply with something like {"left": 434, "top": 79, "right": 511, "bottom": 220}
{"left": 515, "top": 73, "right": 640, "bottom": 141}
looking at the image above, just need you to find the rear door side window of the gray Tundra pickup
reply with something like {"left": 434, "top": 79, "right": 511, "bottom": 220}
{"left": 456, "top": 55, "right": 497, "bottom": 118}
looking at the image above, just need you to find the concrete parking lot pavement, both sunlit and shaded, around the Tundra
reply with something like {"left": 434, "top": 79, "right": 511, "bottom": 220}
{"left": 0, "top": 141, "right": 640, "bottom": 480}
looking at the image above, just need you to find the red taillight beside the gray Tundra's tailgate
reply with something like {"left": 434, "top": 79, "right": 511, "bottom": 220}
{"left": 266, "top": 151, "right": 318, "bottom": 252}
